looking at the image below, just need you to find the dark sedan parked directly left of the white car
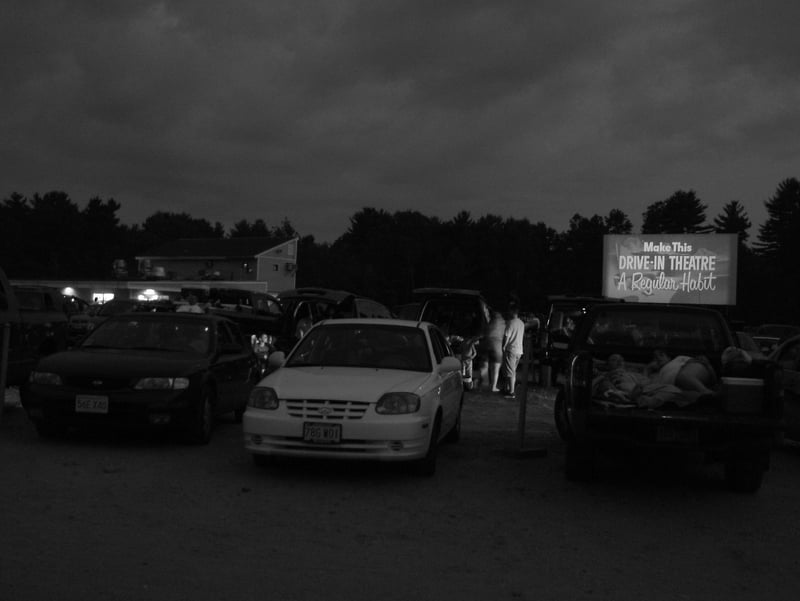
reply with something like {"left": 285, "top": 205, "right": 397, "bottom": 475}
{"left": 21, "top": 313, "right": 258, "bottom": 444}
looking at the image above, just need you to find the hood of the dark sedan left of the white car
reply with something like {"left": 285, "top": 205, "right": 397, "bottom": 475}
{"left": 36, "top": 349, "right": 209, "bottom": 377}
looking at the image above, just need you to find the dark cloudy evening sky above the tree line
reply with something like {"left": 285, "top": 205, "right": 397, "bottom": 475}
{"left": 0, "top": 0, "right": 800, "bottom": 241}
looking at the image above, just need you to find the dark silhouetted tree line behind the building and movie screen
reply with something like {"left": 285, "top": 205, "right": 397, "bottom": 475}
{"left": 0, "top": 178, "right": 800, "bottom": 324}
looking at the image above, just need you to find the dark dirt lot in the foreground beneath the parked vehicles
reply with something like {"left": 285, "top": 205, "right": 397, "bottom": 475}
{"left": 0, "top": 390, "right": 800, "bottom": 601}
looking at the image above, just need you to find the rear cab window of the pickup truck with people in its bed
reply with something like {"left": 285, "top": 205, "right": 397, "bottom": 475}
{"left": 586, "top": 309, "right": 731, "bottom": 354}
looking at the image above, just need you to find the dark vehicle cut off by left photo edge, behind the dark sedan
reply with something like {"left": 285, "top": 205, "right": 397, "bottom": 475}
{"left": 0, "top": 269, "right": 68, "bottom": 390}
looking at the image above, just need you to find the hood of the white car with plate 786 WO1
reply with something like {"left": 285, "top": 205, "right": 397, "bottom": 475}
{"left": 260, "top": 366, "right": 433, "bottom": 403}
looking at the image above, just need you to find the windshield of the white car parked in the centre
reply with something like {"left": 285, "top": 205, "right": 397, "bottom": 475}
{"left": 286, "top": 322, "right": 431, "bottom": 372}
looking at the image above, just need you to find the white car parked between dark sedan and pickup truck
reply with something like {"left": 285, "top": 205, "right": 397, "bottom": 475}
{"left": 247, "top": 319, "right": 464, "bottom": 475}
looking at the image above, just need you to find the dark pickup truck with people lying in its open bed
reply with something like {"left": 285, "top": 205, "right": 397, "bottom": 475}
{"left": 554, "top": 303, "right": 783, "bottom": 492}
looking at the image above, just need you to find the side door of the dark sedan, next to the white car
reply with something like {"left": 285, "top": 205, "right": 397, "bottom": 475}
{"left": 212, "top": 321, "right": 256, "bottom": 413}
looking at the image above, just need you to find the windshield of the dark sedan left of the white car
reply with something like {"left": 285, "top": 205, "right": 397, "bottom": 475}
{"left": 81, "top": 318, "right": 211, "bottom": 354}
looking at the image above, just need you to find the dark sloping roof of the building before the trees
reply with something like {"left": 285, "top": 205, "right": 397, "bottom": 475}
{"left": 136, "top": 237, "right": 293, "bottom": 259}
